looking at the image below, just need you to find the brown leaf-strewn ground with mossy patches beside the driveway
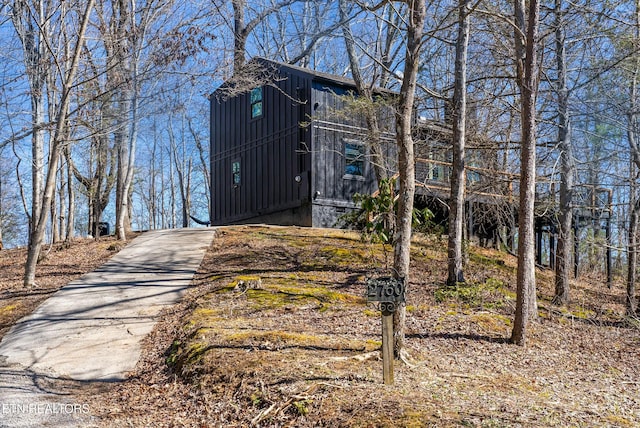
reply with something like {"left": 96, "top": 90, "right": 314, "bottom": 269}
{"left": 0, "top": 226, "right": 640, "bottom": 427}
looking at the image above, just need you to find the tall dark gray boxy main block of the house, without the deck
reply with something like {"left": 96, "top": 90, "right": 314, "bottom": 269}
{"left": 210, "top": 58, "right": 394, "bottom": 231}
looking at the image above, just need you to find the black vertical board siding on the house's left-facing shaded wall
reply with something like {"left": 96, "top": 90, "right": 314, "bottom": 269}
{"left": 211, "top": 62, "right": 310, "bottom": 224}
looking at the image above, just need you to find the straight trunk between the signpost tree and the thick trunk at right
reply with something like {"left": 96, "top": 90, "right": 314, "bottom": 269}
{"left": 447, "top": 0, "right": 469, "bottom": 286}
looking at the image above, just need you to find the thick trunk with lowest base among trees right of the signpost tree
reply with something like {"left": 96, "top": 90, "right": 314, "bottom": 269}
{"left": 511, "top": 0, "right": 540, "bottom": 346}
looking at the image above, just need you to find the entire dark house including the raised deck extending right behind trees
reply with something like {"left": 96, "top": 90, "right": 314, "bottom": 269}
{"left": 210, "top": 58, "right": 612, "bottom": 282}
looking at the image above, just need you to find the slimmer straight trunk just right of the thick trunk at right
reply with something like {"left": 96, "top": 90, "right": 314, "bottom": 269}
{"left": 553, "top": 0, "right": 575, "bottom": 305}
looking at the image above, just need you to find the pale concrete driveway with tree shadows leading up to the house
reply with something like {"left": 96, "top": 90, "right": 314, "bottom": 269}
{"left": 0, "top": 229, "right": 214, "bottom": 426}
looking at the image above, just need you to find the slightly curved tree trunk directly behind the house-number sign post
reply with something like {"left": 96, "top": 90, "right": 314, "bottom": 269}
{"left": 393, "top": 0, "right": 426, "bottom": 358}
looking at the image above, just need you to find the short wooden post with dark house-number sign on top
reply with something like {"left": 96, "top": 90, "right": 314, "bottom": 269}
{"left": 367, "top": 277, "right": 405, "bottom": 385}
